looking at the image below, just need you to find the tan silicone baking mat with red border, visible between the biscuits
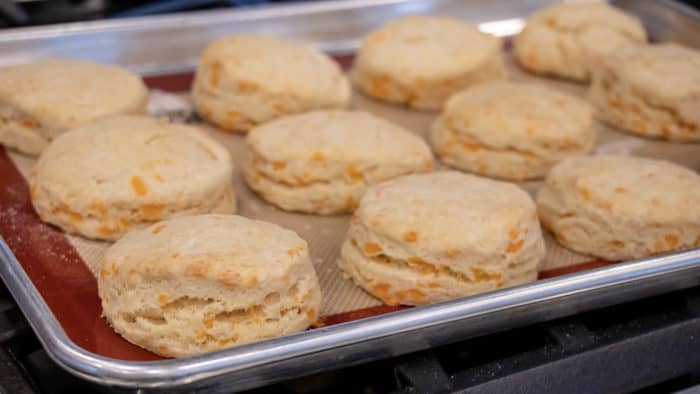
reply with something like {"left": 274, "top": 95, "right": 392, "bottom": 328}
{"left": 0, "top": 45, "right": 700, "bottom": 360}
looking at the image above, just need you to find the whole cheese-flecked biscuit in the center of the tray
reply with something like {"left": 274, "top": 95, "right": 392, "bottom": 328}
{"left": 244, "top": 111, "right": 433, "bottom": 215}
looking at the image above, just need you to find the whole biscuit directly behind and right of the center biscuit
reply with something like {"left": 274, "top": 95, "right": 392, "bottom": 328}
{"left": 431, "top": 82, "right": 596, "bottom": 180}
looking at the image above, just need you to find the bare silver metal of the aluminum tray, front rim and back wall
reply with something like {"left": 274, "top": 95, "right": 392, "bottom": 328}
{"left": 0, "top": 0, "right": 700, "bottom": 392}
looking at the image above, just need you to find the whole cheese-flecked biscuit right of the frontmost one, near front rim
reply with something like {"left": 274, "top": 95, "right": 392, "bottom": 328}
{"left": 339, "top": 171, "right": 545, "bottom": 305}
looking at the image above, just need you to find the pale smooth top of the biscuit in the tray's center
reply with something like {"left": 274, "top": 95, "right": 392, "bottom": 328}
{"left": 248, "top": 111, "right": 432, "bottom": 164}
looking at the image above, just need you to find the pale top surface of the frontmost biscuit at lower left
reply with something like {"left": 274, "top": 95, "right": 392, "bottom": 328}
{"left": 103, "top": 215, "right": 309, "bottom": 286}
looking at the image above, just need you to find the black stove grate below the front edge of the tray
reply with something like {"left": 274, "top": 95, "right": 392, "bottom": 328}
{"left": 0, "top": 278, "right": 700, "bottom": 394}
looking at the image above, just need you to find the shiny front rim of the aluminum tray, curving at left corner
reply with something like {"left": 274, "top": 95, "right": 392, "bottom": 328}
{"left": 0, "top": 239, "right": 700, "bottom": 392}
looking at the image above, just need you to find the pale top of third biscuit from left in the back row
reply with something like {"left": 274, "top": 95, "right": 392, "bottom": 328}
{"left": 356, "top": 15, "right": 501, "bottom": 83}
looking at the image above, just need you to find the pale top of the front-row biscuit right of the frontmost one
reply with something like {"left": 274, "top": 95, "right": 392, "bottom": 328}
{"left": 355, "top": 171, "right": 540, "bottom": 252}
